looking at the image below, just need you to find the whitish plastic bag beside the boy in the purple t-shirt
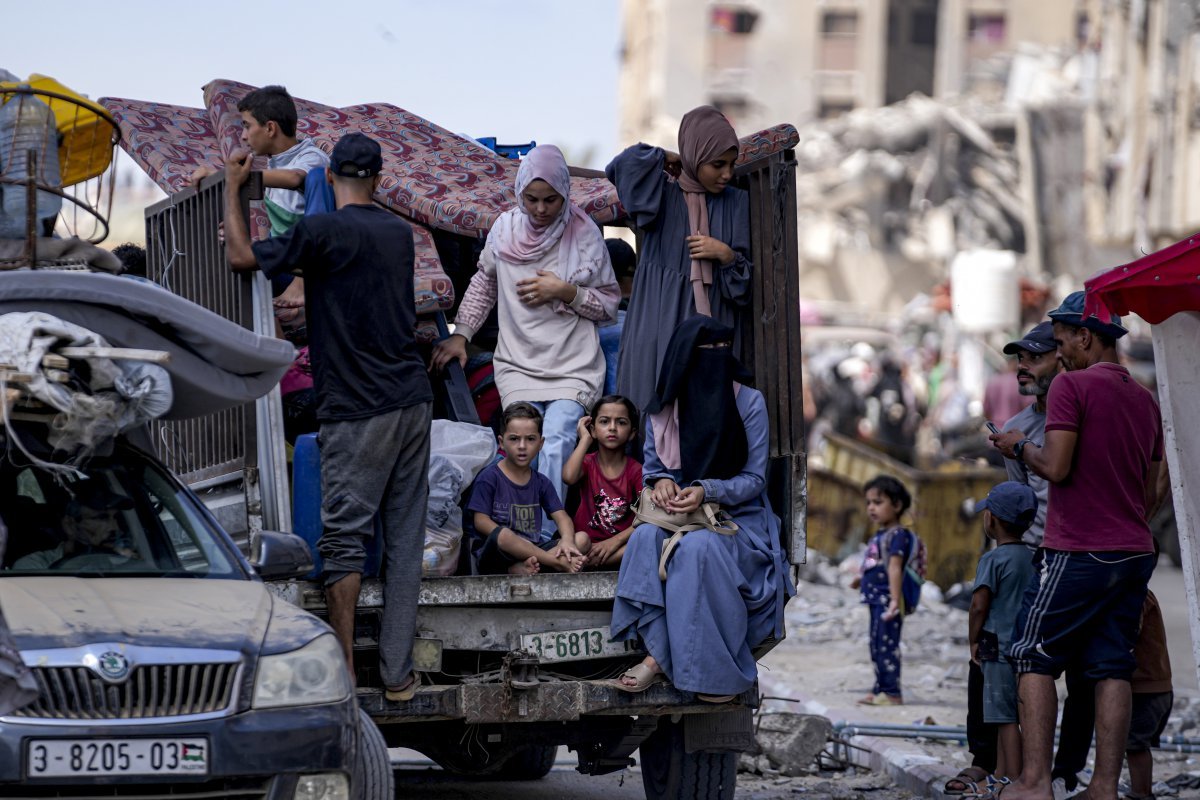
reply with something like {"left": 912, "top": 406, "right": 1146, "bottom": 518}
{"left": 421, "top": 420, "right": 496, "bottom": 577}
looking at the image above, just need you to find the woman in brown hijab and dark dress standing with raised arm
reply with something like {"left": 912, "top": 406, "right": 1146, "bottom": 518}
{"left": 605, "top": 106, "right": 751, "bottom": 411}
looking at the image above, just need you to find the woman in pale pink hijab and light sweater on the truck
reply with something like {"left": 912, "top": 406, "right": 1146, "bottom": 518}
{"left": 433, "top": 144, "right": 620, "bottom": 513}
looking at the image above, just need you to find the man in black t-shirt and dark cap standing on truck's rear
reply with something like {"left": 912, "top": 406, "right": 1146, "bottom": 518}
{"left": 224, "top": 133, "right": 433, "bottom": 700}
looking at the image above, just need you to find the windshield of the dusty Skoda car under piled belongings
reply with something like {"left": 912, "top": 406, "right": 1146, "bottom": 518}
{"left": 0, "top": 449, "right": 246, "bottom": 578}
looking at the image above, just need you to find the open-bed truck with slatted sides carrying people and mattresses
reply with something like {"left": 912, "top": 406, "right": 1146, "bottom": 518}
{"left": 119, "top": 106, "right": 805, "bottom": 800}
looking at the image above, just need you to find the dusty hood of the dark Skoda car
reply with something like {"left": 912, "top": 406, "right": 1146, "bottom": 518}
{"left": 0, "top": 577, "right": 274, "bottom": 655}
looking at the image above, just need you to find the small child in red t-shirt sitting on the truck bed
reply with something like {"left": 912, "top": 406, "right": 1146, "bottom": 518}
{"left": 563, "top": 395, "right": 642, "bottom": 570}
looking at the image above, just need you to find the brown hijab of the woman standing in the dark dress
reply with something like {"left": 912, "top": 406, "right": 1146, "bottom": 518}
{"left": 679, "top": 106, "right": 738, "bottom": 317}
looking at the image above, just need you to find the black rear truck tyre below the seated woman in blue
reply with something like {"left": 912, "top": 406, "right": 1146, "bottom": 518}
{"left": 638, "top": 717, "right": 738, "bottom": 800}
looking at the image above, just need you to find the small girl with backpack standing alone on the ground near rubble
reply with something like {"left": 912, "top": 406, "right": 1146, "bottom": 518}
{"left": 858, "top": 475, "right": 917, "bottom": 705}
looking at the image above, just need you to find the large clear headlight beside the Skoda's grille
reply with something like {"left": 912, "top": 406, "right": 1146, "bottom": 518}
{"left": 251, "top": 633, "right": 350, "bottom": 709}
